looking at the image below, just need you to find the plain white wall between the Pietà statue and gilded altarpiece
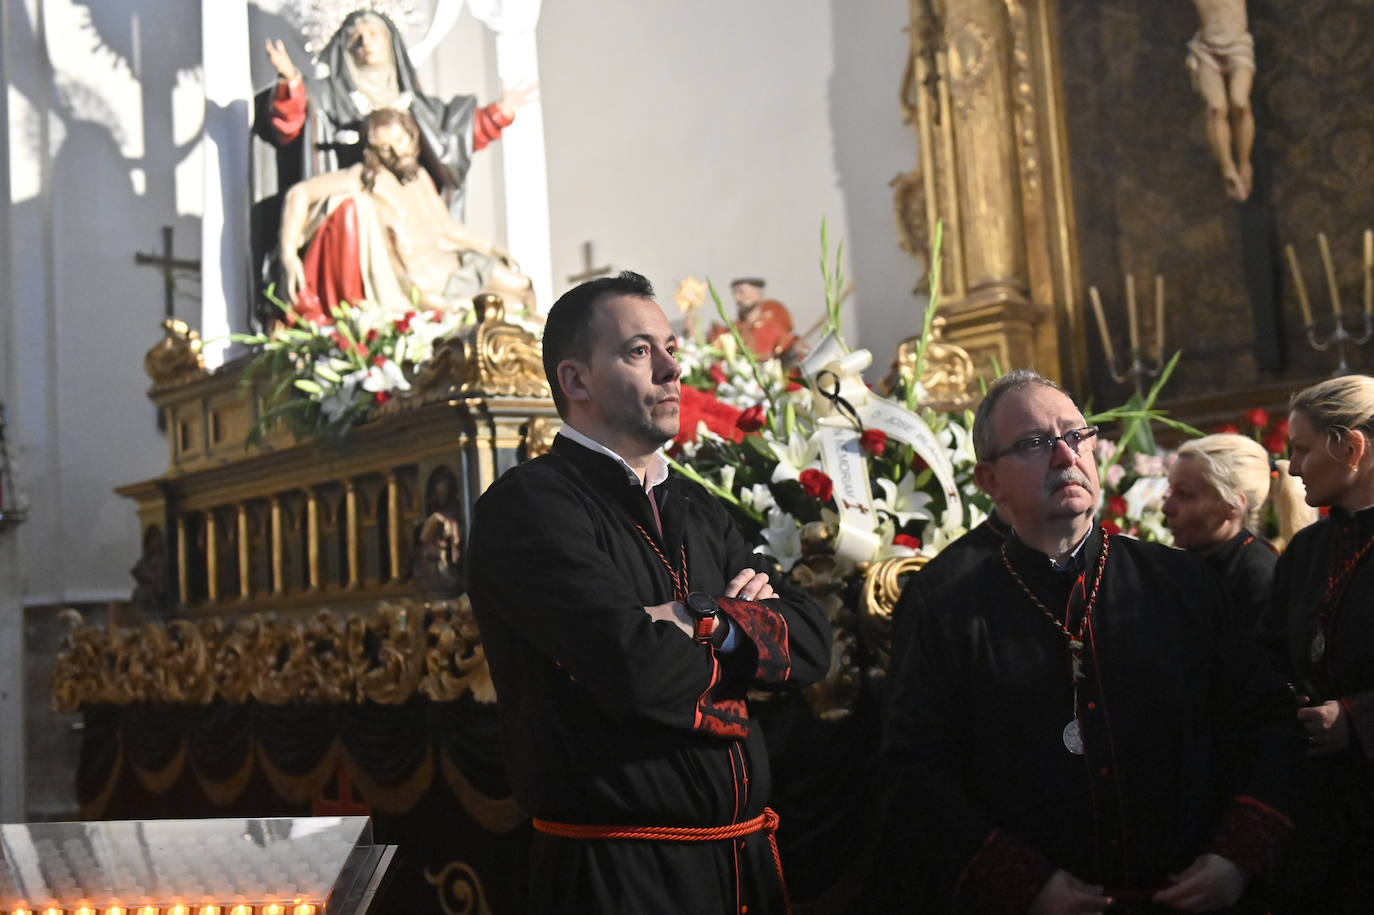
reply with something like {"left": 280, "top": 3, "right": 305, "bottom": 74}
{"left": 539, "top": 0, "right": 919, "bottom": 364}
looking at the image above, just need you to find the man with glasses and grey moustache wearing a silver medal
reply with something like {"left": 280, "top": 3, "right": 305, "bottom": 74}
{"left": 882, "top": 370, "right": 1301, "bottom": 912}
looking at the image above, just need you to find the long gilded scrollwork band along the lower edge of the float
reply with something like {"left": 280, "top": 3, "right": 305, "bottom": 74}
{"left": 51, "top": 596, "right": 496, "bottom": 714}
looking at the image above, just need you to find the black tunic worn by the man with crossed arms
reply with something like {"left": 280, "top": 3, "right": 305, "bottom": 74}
{"left": 469, "top": 436, "right": 831, "bottom": 915}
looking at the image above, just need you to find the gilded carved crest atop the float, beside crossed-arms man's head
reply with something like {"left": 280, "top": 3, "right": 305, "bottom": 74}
{"left": 389, "top": 293, "right": 548, "bottom": 409}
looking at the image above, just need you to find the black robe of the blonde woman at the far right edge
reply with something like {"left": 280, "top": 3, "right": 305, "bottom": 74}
{"left": 1256, "top": 508, "right": 1374, "bottom": 912}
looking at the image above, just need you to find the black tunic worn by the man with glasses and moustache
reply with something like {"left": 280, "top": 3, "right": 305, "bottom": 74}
{"left": 882, "top": 529, "right": 1301, "bottom": 912}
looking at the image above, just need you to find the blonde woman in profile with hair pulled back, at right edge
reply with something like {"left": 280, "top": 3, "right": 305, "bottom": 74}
{"left": 1259, "top": 375, "right": 1374, "bottom": 912}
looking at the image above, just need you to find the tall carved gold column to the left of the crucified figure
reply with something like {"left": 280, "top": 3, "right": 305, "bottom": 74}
{"left": 894, "top": 0, "right": 1081, "bottom": 385}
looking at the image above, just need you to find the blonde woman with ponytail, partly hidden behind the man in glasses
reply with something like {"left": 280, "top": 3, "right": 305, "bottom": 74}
{"left": 1164, "top": 433, "right": 1316, "bottom": 620}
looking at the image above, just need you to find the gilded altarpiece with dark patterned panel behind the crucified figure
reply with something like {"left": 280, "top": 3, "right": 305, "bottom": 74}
{"left": 897, "top": 0, "right": 1374, "bottom": 423}
